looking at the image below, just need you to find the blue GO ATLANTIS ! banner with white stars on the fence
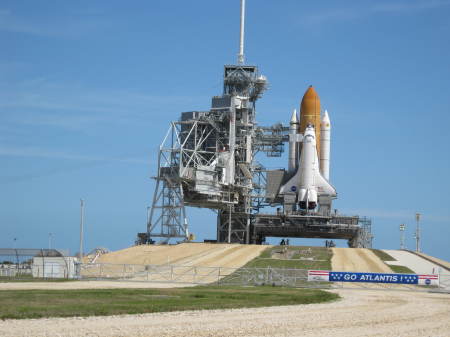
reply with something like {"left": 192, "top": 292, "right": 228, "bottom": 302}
{"left": 308, "top": 270, "right": 439, "bottom": 285}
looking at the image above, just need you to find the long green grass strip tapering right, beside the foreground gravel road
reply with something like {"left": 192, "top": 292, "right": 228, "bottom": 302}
{"left": 0, "top": 286, "right": 339, "bottom": 319}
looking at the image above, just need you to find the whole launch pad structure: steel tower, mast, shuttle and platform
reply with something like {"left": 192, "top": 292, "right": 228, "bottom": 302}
{"left": 137, "top": 1, "right": 373, "bottom": 247}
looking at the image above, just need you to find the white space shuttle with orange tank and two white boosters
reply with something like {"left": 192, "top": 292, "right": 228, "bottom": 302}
{"left": 279, "top": 86, "right": 337, "bottom": 215}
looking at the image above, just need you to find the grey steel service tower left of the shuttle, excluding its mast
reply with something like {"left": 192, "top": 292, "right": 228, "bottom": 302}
{"left": 140, "top": 66, "right": 287, "bottom": 243}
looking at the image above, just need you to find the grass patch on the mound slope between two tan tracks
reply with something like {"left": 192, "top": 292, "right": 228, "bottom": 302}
{"left": 243, "top": 246, "right": 333, "bottom": 270}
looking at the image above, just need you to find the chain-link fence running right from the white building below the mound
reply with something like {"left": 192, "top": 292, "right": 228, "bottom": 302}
{"left": 79, "top": 263, "right": 450, "bottom": 291}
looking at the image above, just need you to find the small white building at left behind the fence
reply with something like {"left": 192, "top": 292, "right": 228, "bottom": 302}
{"left": 32, "top": 256, "right": 77, "bottom": 278}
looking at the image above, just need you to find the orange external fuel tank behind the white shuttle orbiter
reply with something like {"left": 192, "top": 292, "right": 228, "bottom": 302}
{"left": 299, "top": 85, "right": 320, "bottom": 158}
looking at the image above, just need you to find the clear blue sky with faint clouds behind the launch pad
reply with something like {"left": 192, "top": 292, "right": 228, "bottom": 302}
{"left": 0, "top": 0, "right": 450, "bottom": 260}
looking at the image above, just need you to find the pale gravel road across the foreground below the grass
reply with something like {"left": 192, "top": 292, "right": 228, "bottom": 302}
{"left": 0, "top": 290, "right": 450, "bottom": 337}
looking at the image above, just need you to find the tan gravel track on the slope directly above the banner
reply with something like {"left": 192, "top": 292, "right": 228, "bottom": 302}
{"left": 331, "top": 248, "right": 392, "bottom": 273}
